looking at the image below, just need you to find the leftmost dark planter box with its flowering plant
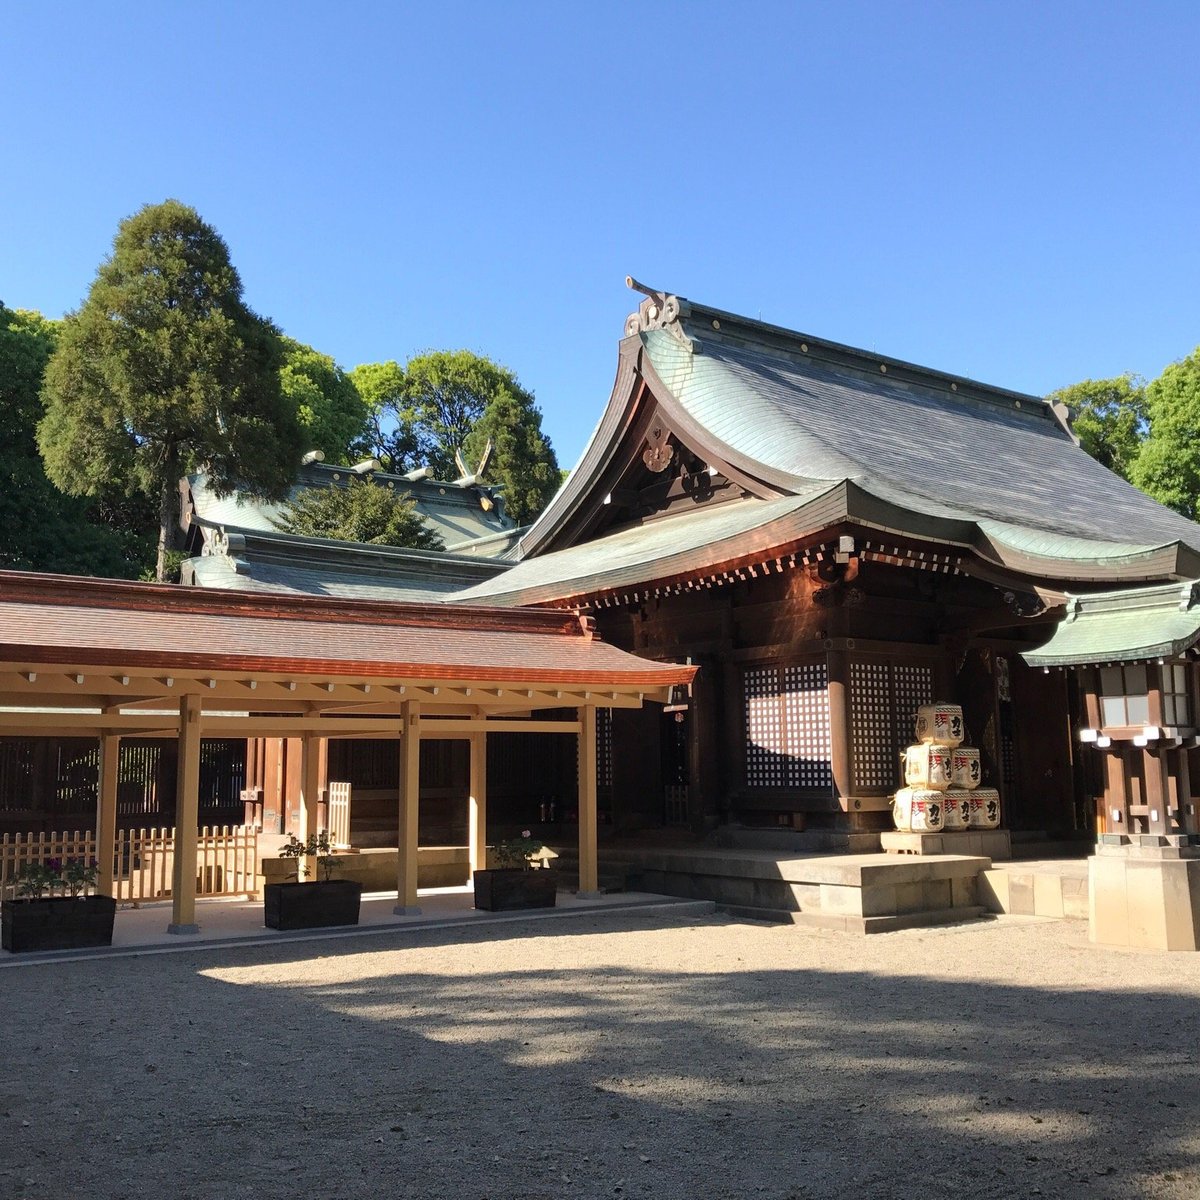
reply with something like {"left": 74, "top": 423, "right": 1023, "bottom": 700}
{"left": 0, "top": 858, "right": 116, "bottom": 954}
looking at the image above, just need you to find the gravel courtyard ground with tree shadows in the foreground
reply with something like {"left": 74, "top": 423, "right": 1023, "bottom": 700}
{"left": 0, "top": 914, "right": 1200, "bottom": 1200}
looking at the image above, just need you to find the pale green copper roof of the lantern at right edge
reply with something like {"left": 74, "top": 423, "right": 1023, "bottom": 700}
{"left": 1021, "top": 582, "right": 1200, "bottom": 667}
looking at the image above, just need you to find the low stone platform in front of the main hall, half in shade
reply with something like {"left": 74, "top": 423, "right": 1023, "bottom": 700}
{"left": 601, "top": 845, "right": 991, "bottom": 934}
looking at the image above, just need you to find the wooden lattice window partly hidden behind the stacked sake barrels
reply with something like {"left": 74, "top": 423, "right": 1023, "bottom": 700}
{"left": 850, "top": 659, "right": 934, "bottom": 791}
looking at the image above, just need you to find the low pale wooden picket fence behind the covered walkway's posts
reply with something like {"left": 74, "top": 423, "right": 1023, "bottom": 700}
{"left": 0, "top": 826, "right": 258, "bottom": 901}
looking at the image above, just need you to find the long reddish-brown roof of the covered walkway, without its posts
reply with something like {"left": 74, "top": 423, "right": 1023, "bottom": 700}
{"left": 0, "top": 572, "right": 695, "bottom": 737}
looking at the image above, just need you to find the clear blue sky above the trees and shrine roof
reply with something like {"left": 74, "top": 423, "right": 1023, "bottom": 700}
{"left": 0, "top": 0, "right": 1200, "bottom": 466}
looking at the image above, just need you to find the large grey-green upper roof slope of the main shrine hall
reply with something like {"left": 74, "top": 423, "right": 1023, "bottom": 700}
{"left": 641, "top": 319, "right": 1200, "bottom": 558}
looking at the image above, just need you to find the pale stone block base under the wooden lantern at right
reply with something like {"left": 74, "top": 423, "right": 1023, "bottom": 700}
{"left": 1087, "top": 838, "right": 1200, "bottom": 950}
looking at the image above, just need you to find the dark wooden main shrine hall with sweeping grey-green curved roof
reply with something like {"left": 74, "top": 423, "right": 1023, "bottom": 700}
{"left": 454, "top": 281, "right": 1200, "bottom": 846}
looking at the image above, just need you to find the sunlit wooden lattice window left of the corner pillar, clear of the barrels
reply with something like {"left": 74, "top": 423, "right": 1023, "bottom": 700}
{"left": 744, "top": 662, "right": 833, "bottom": 788}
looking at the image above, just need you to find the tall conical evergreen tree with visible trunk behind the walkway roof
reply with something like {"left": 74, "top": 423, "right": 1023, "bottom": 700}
{"left": 38, "top": 200, "right": 304, "bottom": 578}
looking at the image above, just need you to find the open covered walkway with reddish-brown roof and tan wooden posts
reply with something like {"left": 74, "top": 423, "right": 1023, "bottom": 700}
{"left": 0, "top": 572, "right": 695, "bottom": 934}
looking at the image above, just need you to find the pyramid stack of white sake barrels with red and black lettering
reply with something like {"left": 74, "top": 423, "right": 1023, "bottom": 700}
{"left": 892, "top": 704, "right": 1000, "bottom": 833}
